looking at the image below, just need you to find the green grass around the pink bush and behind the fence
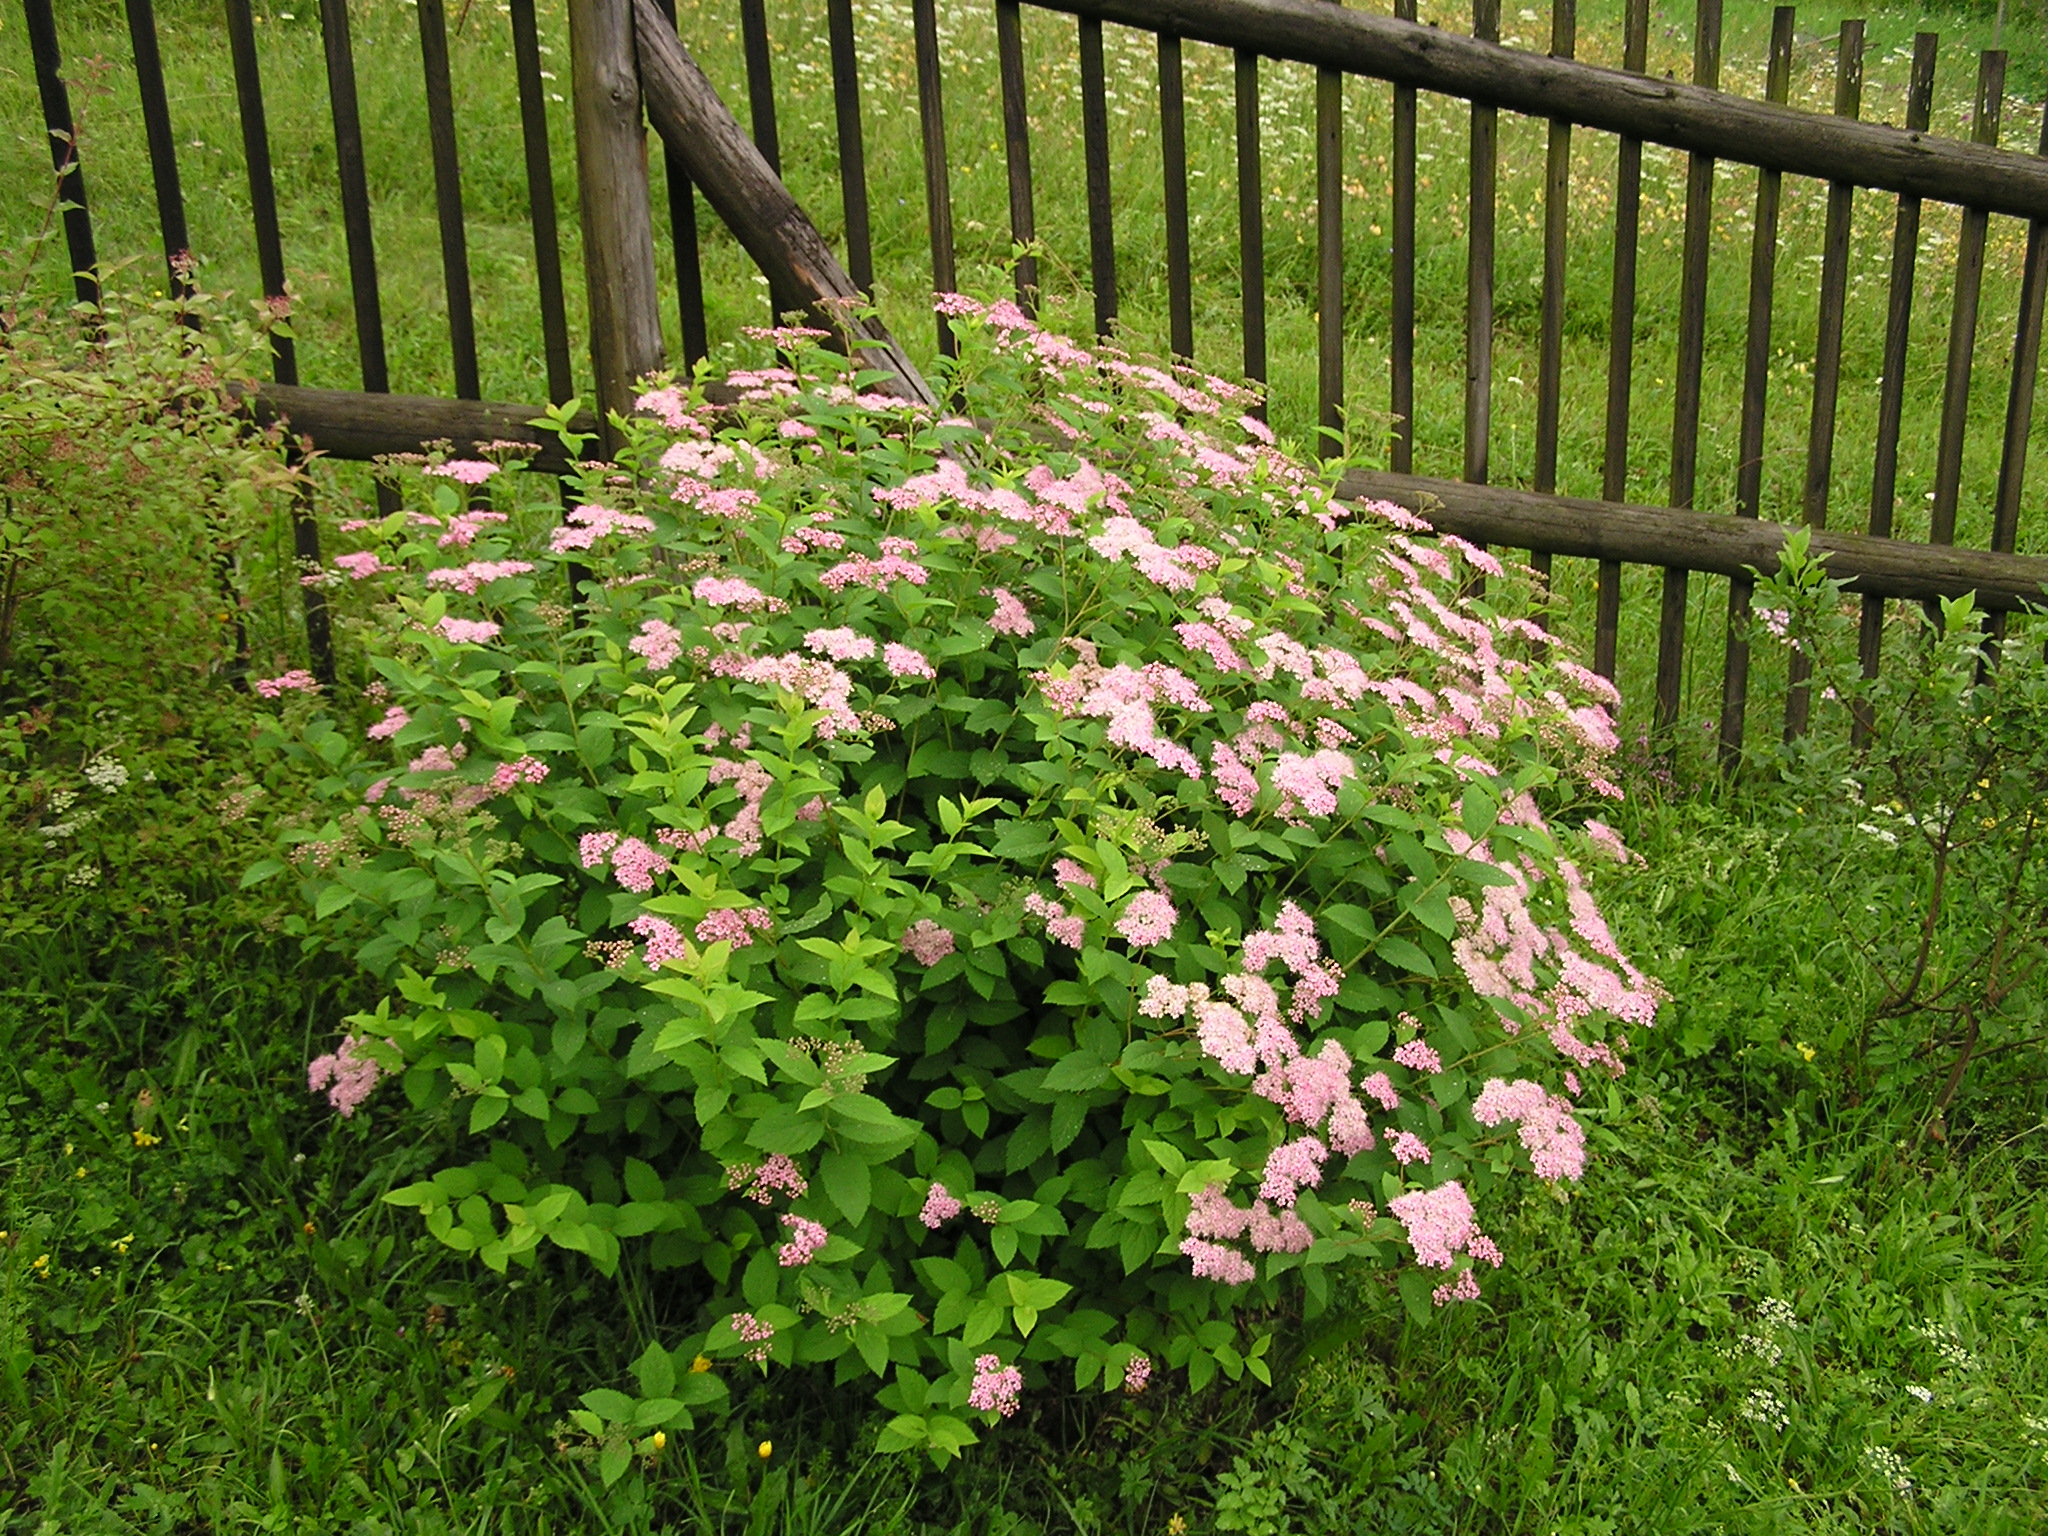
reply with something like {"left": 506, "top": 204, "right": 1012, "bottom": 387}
{"left": 0, "top": 0, "right": 2048, "bottom": 1536}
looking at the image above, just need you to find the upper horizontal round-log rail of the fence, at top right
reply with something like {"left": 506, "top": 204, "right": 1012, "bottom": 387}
{"left": 1030, "top": 0, "right": 2048, "bottom": 219}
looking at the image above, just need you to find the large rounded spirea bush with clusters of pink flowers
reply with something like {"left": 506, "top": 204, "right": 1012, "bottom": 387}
{"left": 260, "top": 299, "right": 1657, "bottom": 1475}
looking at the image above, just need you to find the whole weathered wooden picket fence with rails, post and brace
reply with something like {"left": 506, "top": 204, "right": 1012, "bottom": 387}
{"left": 25, "top": 0, "right": 2048, "bottom": 758}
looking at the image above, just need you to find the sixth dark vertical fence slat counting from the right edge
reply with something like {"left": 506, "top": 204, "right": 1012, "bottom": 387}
{"left": 1655, "top": 0, "right": 1720, "bottom": 733}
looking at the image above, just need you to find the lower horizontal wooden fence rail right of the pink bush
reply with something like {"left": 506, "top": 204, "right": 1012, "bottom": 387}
{"left": 1337, "top": 469, "right": 2048, "bottom": 612}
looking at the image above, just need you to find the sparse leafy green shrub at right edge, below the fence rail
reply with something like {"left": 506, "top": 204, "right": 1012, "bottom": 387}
{"left": 1761, "top": 537, "right": 2048, "bottom": 1139}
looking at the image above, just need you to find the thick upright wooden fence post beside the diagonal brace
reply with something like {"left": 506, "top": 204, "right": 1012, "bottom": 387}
{"left": 569, "top": 0, "right": 662, "bottom": 455}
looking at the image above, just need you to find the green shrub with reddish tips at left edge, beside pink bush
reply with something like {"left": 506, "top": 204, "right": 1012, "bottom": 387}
{"left": 0, "top": 274, "right": 315, "bottom": 948}
